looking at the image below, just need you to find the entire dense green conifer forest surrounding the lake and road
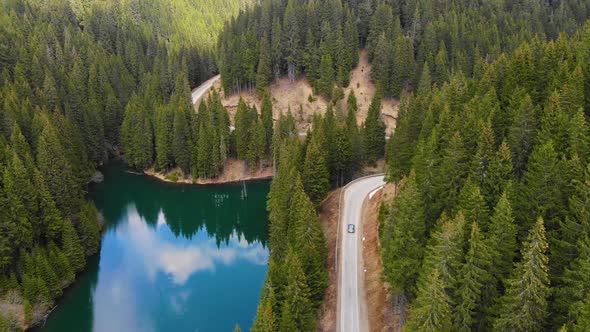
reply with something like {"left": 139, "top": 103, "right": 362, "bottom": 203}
{"left": 0, "top": 0, "right": 590, "bottom": 332}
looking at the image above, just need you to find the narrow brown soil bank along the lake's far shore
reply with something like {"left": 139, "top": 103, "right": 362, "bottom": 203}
{"left": 144, "top": 159, "right": 273, "bottom": 184}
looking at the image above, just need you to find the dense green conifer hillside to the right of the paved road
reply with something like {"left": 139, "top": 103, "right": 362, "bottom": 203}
{"left": 381, "top": 23, "right": 590, "bottom": 331}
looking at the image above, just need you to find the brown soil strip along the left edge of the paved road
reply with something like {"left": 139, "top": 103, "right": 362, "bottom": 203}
{"left": 318, "top": 189, "right": 340, "bottom": 332}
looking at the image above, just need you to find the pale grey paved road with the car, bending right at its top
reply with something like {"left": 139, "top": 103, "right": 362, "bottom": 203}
{"left": 337, "top": 175, "right": 385, "bottom": 332}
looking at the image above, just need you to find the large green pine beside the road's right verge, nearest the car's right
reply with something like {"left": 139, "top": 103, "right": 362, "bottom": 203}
{"left": 380, "top": 172, "right": 426, "bottom": 295}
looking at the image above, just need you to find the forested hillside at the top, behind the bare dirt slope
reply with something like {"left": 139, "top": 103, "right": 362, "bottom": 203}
{"left": 218, "top": 0, "right": 590, "bottom": 99}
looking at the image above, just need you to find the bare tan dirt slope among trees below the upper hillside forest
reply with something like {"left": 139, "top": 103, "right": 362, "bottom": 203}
{"left": 198, "top": 51, "right": 399, "bottom": 134}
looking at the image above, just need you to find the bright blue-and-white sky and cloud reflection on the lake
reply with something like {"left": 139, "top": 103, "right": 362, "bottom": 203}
{"left": 93, "top": 204, "right": 269, "bottom": 332}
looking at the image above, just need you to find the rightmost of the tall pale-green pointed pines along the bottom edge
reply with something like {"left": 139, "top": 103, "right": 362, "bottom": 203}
{"left": 494, "top": 218, "right": 550, "bottom": 331}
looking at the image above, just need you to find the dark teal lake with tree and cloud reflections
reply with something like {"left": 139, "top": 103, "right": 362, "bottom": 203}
{"left": 40, "top": 164, "right": 269, "bottom": 332}
